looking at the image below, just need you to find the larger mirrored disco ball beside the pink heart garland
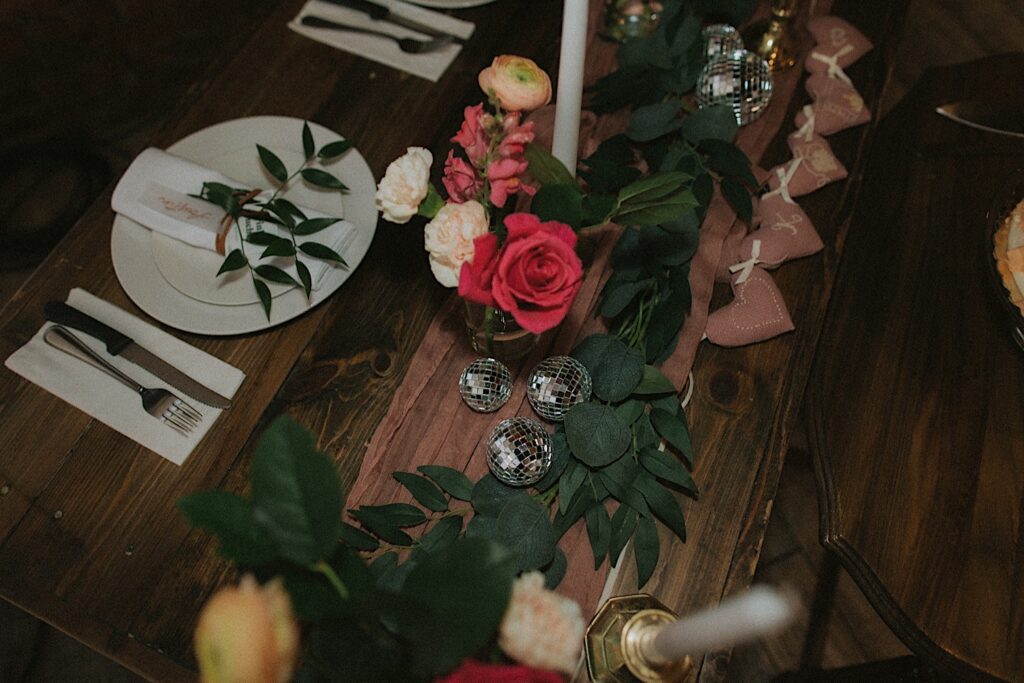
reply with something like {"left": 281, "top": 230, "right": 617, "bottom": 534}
{"left": 697, "top": 50, "right": 771, "bottom": 126}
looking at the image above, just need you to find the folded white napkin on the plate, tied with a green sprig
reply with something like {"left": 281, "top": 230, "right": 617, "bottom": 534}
{"left": 111, "top": 147, "right": 355, "bottom": 289}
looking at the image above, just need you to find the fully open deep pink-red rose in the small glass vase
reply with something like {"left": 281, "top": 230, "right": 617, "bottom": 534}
{"left": 459, "top": 213, "right": 583, "bottom": 334}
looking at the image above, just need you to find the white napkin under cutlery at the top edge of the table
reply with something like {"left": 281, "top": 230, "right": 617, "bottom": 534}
{"left": 288, "top": 0, "right": 475, "bottom": 82}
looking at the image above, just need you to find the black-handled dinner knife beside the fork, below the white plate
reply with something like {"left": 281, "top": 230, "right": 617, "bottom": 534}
{"left": 43, "top": 301, "right": 231, "bottom": 409}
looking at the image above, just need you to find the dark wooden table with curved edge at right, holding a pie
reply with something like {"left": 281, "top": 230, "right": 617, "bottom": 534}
{"left": 807, "top": 53, "right": 1024, "bottom": 681}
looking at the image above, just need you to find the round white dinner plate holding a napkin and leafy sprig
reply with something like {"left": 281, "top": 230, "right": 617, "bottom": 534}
{"left": 111, "top": 116, "right": 377, "bottom": 335}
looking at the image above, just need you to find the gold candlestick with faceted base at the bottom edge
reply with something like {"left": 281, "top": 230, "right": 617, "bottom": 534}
{"left": 585, "top": 594, "right": 696, "bottom": 683}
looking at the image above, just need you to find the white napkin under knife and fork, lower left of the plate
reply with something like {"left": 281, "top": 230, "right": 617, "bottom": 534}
{"left": 4, "top": 289, "right": 245, "bottom": 465}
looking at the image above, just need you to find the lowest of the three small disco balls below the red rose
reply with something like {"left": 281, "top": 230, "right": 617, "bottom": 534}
{"left": 487, "top": 418, "right": 551, "bottom": 486}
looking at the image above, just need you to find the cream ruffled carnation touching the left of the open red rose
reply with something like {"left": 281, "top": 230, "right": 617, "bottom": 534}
{"left": 423, "top": 200, "right": 487, "bottom": 287}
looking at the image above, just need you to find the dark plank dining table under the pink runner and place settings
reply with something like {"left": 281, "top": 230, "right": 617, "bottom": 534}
{"left": 0, "top": 0, "right": 905, "bottom": 680}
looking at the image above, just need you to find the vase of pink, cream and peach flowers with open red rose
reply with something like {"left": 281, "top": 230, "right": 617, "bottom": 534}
{"left": 377, "top": 55, "right": 583, "bottom": 357}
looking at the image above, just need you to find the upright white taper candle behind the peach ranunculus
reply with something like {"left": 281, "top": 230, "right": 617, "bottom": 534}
{"left": 551, "top": 0, "right": 590, "bottom": 175}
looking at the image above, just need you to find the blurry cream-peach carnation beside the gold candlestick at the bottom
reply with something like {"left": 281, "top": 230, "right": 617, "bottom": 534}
{"left": 498, "top": 571, "right": 585, "bottom": 674}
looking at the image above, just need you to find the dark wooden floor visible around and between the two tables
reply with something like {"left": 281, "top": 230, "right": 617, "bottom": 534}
{"left": 0, "top": 0, "right": 1024, "bottom": 683}
